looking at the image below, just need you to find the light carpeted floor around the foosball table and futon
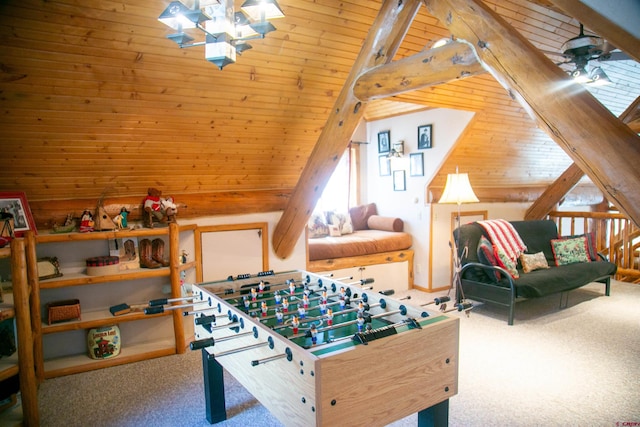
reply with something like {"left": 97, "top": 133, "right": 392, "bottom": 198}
{"left": 5, "top": 282, "right": 640, "bottom": 427}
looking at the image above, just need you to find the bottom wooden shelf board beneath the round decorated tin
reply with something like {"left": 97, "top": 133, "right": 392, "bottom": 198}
{"left": 44, "top": 341, "right": 176, "bottom": 379}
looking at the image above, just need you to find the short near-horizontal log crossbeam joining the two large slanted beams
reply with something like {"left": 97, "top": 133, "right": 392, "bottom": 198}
{"left": 353, "top": 41, "right": 487, "bottom": 101}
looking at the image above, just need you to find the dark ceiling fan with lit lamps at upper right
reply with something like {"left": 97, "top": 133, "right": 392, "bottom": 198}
{"left": 542, "top": 24, "right": 630, "bottom": 83}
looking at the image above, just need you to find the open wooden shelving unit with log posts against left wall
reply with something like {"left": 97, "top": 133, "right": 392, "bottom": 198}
{"left": 29, "top": 224, "right": 196, "bottom": 378}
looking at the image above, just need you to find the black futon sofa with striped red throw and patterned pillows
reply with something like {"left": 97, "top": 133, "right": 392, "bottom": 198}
{"left": 454, "top": 220, "right": 616, "bottom": 325}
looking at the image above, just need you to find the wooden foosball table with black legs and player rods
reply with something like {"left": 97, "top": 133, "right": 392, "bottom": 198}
{"left": 185, "top": 270, "right": 459, "bottom": 426}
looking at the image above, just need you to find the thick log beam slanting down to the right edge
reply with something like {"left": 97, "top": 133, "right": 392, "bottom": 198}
{"left": 424, "top": 0, "right": 640, "bottom": 229}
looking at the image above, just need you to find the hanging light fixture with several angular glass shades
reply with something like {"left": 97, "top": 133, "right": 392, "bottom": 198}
{"left": 158, "top": 0, "right": 284, "bottom": 70}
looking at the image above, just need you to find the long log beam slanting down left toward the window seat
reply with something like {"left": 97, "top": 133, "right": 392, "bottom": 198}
{"left": 272, "top": 0, "right": 420, "bottom": 258}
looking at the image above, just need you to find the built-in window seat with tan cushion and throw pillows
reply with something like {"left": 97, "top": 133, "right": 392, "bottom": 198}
{"left": 307, "top": 203, "right": 413, "bottom": 280}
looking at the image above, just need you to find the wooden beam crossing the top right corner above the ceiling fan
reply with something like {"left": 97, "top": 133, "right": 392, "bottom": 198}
{"left": 551, "top": 0, "right": 640, "bottom": 62}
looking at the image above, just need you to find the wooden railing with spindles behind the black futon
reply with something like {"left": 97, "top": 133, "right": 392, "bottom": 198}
{"left": 548, "top": 211, "right": 640, "bottom": 283}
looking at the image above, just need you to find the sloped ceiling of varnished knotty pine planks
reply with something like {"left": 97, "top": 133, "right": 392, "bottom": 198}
{"left": 0, "top": 0, "right": 640, "bottom": 229}
